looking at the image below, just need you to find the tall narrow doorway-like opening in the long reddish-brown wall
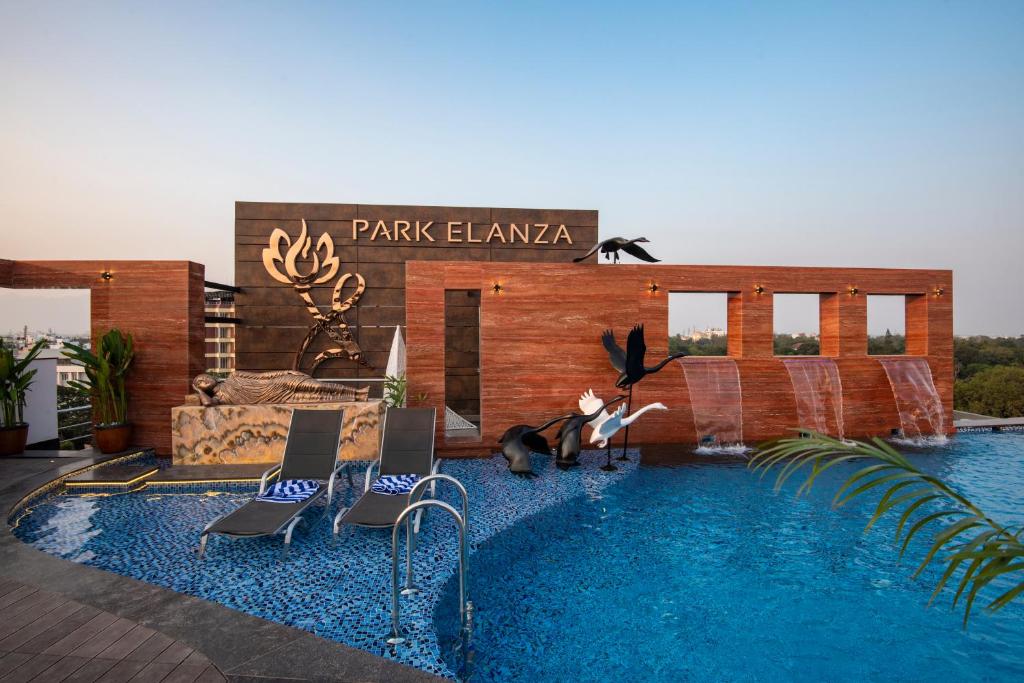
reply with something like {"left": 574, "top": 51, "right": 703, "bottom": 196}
{"left": 444, "top": 290, "right": 480, "bottom": 440}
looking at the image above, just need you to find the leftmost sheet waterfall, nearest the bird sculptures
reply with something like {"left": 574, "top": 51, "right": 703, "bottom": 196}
{"left": 679, "top": 356, "right": 743, "bottom": 446}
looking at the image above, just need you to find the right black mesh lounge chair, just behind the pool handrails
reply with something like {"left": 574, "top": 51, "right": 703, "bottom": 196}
{"left": 334, "top": 408, "right": 440, "bottom": 536}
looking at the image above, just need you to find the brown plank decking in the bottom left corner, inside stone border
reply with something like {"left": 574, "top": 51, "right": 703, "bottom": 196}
{"left": 0, "top": 579, "right": 227, "bottom": 683}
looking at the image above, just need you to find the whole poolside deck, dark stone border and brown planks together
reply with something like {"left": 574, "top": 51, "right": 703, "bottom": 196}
{"left": 0, "top": 452, "right": 442, "bottom": 683}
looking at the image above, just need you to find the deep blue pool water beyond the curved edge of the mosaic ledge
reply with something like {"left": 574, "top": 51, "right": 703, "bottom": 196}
{"left": 438, "top": 434, "right": 1024, "bottom": 682}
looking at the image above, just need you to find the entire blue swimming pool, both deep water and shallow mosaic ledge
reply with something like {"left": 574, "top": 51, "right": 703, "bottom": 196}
{"left": 9, "top": 433, "right": 1024, "bottom": 681}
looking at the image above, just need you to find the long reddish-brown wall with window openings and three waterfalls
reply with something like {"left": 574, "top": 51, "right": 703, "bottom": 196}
{"left": 407, "top": 262, "right": 952, "bottom": 450}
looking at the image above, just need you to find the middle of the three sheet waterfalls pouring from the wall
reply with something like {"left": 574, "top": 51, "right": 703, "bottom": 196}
{"left": 782, "top": 358, "right": 843, "bottom": 439}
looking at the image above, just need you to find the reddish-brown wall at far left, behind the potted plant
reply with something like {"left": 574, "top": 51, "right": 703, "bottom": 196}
{"left": 6, "top": 261, "right": 206, "bottom": 455}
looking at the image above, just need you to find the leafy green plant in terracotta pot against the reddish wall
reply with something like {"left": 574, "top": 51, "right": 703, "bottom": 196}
{"left": 65, "top": 328, "right": 135, "bottom": 453}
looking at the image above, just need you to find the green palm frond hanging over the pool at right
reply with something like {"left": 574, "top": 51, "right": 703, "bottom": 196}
{"left": 749, "top": 432, "right": 1024, "bottom": 627}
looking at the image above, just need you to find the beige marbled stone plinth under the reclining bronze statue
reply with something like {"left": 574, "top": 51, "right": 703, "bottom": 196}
{"left": 171, "top": 400, "right": 383, "bottom": 465}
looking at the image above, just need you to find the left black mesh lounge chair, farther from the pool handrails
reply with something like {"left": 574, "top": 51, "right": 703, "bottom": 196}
{"left": 199, "top": 410, "right": 352, "bottom": 559}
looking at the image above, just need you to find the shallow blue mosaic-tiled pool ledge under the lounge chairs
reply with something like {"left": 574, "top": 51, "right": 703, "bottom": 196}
{"left": 14, "top": 450, "right": 638, "bottom": 678}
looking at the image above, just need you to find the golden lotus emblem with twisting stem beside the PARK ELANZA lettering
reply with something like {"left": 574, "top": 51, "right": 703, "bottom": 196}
{"left": 263, "top": 220, "right": 370, "bottom": 375}
